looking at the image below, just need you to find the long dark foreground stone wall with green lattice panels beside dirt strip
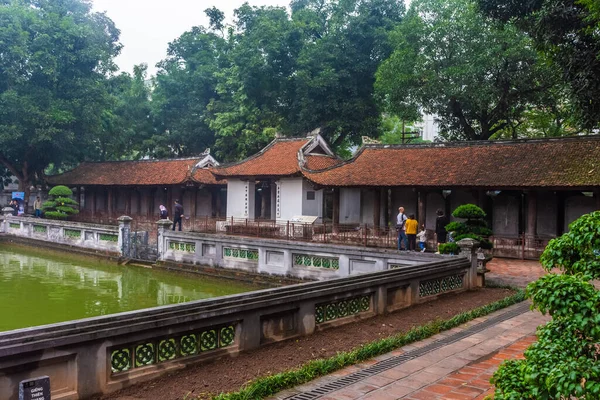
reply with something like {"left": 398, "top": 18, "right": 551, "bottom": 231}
{"left": 0, "top": 255, "right": 477, "bottom": 400}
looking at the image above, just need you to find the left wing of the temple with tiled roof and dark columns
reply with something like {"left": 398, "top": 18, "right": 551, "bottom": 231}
{"left": 48, "top": 151, "right": 227, "bottom": 227}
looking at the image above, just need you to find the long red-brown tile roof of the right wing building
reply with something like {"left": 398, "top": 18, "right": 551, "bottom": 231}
{"left": 303, "top": 136, "right": 600, "bottom": 188}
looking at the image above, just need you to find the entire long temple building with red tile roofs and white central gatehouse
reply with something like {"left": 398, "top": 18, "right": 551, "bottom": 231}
{"left": 49, "top": 132, "right": 600, "bottom": 258}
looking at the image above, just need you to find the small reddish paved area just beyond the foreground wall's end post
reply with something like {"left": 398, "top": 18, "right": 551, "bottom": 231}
{"left": 485, "top": 258, "right": 546, "bottom": 288}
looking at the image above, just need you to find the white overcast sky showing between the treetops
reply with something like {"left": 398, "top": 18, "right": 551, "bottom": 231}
{"left": 93, "top": 0, "right": 289, "bottom": 75}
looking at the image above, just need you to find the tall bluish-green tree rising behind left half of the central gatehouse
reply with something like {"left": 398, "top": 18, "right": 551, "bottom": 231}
{"left": 208, "top": 4, "right": 302, "bottom": 160}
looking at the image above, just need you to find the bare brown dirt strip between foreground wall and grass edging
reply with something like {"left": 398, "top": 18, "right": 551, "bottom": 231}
{"left": 95, "top": 288, "right": 513, "bottom": 400}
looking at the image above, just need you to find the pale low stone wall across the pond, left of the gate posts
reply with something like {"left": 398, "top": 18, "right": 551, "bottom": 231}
{"left": 0, "top": 215, "right": 122, "bottom": 254}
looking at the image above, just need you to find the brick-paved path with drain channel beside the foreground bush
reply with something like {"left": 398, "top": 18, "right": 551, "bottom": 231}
{"left": 273, "top": 304, "right": 549, "bottom": 400}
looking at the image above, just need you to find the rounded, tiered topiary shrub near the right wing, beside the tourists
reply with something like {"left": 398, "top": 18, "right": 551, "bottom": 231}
{"left": 440, "top": 204, "right": 492, "bottom": 248}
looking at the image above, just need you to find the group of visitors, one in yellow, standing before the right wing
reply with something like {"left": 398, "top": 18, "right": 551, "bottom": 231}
{"left": 396, "top": 207, "right": 448, "bottom": 252}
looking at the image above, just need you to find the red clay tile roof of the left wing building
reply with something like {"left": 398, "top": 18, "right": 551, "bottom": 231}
{"left": 48, "top": 158, "right": 223, "bottom": 186}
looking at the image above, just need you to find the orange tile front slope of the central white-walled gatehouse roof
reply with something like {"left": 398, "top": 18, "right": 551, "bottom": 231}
{"left": 211, "top": 138, "right": 312, "bottom": 177}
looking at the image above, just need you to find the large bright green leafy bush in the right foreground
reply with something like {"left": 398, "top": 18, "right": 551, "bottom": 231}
{"left": 492, "top": 211, "right": 600, "bottom": 400}
